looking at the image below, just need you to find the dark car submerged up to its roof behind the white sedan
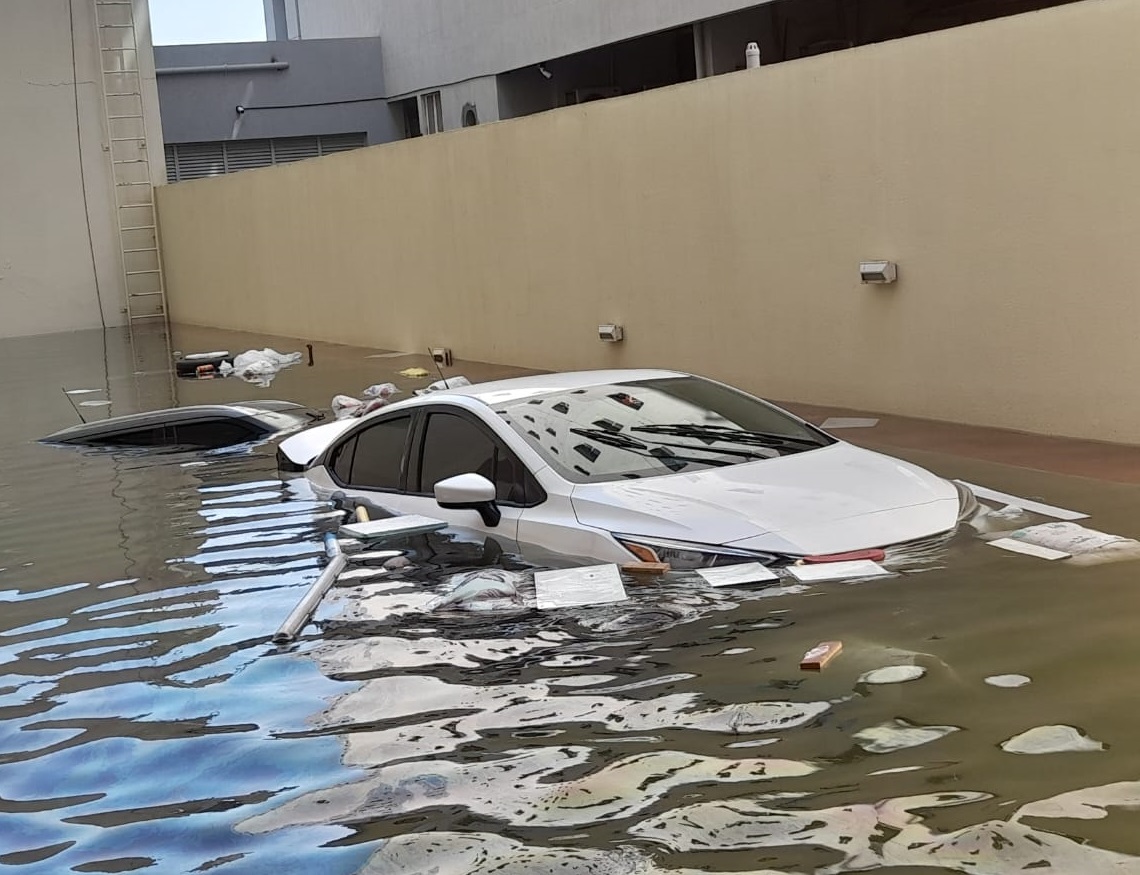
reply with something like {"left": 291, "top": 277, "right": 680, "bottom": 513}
{"left": 40, "top": 401, "right": 323, "bottom": 449}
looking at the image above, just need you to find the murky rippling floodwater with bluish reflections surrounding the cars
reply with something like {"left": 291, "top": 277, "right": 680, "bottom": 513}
{"left": 0, "top": 329, "right": 1140, "bottom": 875}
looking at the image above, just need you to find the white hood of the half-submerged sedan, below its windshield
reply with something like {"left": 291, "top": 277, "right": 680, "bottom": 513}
{"left": 571, "top": 442, "right": 959, "bottom": 555}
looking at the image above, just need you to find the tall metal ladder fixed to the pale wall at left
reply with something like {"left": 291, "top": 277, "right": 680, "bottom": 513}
{"left": 93, "top": 0, "right": 170, "bottom": 328}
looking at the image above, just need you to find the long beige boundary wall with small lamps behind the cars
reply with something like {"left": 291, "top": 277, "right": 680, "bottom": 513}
{"left": 160, "top": 0, "right": 1140, "bottom": 442}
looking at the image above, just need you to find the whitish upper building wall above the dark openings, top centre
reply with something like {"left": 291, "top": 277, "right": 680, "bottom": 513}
{"left": 295, "top": 0, "right": 765, "bottom": 97}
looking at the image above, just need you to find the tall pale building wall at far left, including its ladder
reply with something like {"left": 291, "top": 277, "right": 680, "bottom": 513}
{"left": 0, "top": 0, "right": 163, "bottom": 336}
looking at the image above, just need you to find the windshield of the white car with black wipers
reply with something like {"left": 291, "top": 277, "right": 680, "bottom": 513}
{"left": 495, "top": 377, "right": 834, "bottom": 483}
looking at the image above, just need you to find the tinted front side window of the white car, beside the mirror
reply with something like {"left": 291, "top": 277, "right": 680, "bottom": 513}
{"left": 418, "top": 412, "right": 539, "bottom": 505}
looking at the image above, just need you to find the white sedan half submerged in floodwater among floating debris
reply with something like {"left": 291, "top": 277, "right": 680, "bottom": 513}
{"left": 278, "top": 370, "right": 975, "bottom": 569}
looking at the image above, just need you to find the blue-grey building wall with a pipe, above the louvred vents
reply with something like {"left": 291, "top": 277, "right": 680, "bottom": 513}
{"left": 154, "top": 39, "right": 400, "bottom": 144}
